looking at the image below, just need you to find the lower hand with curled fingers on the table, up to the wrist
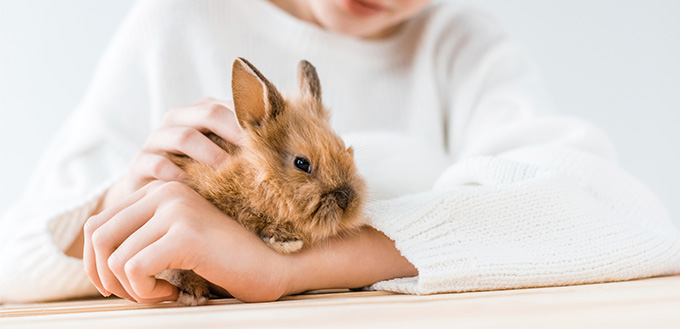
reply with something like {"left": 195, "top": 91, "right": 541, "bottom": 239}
{"left": 83, "top": 181, "right": 288, "bottom": 303}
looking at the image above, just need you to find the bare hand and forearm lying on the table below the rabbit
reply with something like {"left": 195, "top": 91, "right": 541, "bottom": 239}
{"left": 83, "top": 181, "right": 417, "bottom": 303}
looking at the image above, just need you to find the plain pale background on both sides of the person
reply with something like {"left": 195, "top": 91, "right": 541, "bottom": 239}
{"left": 0, "top": 0, "right": 680, "bottom": 224}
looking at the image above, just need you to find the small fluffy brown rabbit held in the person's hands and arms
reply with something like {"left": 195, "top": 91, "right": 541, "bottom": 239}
{"left": 158, "top": 58, "right": 365, "bottom": 305}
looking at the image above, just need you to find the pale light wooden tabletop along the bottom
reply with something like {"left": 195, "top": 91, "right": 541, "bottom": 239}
{"left": 0, "top": 276, "right": 680, "bottom": 329}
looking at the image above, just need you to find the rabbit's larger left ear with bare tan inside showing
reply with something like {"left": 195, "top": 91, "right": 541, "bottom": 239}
{"left": 231, "top": 57, "right": 285, "bottom": 129}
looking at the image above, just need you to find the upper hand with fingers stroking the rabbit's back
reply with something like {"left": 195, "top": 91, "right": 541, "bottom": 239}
{"left": 98, "top": 98, "right": 241, "bottom": 210}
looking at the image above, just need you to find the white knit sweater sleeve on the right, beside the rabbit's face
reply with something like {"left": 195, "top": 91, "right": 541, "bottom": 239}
{"left": 366, "top": 32, "right": 680, "bottom": 294}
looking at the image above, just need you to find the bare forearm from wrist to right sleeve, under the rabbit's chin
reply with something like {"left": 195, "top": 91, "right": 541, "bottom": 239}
{"left": 286, "top": 227, "right": 418, "bottom": 295}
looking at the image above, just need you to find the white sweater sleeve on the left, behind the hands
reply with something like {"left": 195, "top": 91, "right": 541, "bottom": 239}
{"left": 0, "top": 0, "right": 155, "bottom": 302}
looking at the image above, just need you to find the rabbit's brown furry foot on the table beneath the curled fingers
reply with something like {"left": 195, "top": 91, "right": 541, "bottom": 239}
{"left": 156, "top": 270, "right": 210, "bottom": 306}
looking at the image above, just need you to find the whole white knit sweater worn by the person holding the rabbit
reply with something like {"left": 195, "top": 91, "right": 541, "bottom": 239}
{"left": 0, "top": 0, "right": 680, "bottom": 301}
